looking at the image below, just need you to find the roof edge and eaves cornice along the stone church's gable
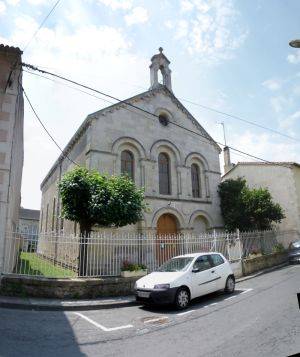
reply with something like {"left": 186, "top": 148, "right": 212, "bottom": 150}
{"left": 40, "top": 84, "right": 221, "bottom": 189}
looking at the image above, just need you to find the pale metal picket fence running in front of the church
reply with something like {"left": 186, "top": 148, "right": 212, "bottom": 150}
{"left": 4, "top": 230, "right": 292, "bottom": 277}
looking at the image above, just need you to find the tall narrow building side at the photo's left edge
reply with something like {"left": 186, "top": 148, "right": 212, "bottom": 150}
{"left": 0, "top": 45, "right": 24, "bottom": 273}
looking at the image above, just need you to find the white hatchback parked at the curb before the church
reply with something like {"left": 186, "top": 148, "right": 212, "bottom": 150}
{"left": 135, "top": 252, "right": 235, "bottom": 309}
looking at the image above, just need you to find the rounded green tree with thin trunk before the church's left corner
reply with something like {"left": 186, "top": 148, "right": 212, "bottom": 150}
{"left": 59, "top": 167, "right": 145, "bottom": 275}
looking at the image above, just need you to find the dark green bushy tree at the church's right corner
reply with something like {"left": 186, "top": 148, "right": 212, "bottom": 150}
{"left": 218, "top": 177, "right": 284, "bottom": 231}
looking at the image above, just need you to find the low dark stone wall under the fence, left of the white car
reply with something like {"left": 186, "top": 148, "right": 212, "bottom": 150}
{"left": 0, "top": 275, "right": 139, "bottom": 299}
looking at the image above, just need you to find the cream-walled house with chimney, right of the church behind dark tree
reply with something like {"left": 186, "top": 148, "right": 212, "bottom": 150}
{"left": 222, "top": 147, "right": 300, "bottom": 243}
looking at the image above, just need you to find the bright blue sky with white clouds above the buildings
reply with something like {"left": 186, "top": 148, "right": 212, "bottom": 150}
{"left": 0, "top": 0, "right": 300, "bottom": 209}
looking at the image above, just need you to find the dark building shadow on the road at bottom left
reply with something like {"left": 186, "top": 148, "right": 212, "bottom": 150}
{"left": 0, "top": 308, "right": 85, "bottom": 357}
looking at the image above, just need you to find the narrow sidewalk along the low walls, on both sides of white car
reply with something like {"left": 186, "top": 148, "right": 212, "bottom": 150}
{"left": 0, "top": 263, "right": 287, "bottom": 311}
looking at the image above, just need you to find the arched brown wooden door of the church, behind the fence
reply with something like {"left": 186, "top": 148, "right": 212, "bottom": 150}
{"left": 156, "top": 213, "right": 179, "bottom": 265}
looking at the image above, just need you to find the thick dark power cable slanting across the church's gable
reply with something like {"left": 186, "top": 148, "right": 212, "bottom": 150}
{"left": 22, "top": 63, "right": 294, "bottom": 166}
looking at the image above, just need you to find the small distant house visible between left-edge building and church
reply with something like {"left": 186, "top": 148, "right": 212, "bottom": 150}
{"left": 19, "top": 207, "right": 40, "bottom": 252}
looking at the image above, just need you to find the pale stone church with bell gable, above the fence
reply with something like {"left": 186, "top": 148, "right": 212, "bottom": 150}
{"left": 40, "top": 48, "right": 223, "bottom": 234}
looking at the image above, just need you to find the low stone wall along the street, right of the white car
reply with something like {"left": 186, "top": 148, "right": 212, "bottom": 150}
{"left": 242, "top": 253, "right": 288, "bottom": 275}
